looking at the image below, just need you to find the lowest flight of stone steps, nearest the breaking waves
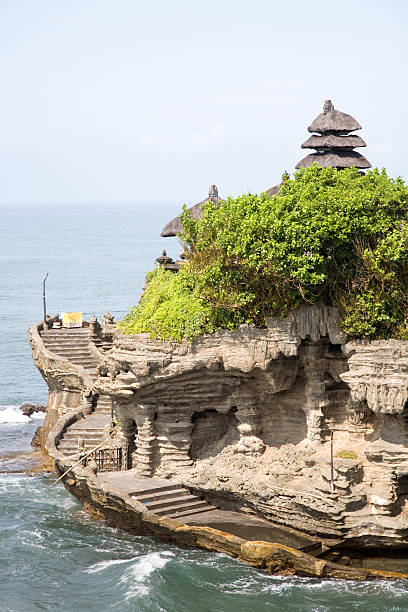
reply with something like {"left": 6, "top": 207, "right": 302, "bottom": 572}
{"left": 130, "top": 479, "right": 215, "bottom": 519}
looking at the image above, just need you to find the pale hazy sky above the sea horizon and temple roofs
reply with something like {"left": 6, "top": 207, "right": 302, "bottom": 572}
{"left": 0, "top": 0, "right": 408, "bottom": 204}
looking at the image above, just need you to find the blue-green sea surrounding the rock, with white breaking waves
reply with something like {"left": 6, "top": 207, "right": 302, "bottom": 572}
{"left": 0, "top": 202, "right": 408, "bottom": 612}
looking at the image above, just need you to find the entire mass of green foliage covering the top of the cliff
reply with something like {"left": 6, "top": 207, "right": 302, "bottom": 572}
{"left": 118, "top": 166, "right": 408, "bottom": 340}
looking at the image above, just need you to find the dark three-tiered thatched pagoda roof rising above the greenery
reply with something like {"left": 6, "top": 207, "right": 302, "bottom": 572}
{"left": 296, "top": 100, "right": 371, "bottom": 169}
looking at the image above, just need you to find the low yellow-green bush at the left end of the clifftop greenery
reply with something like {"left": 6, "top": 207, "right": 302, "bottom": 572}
{"left": 118, "top": 267, "right": 213, "bottom": 341}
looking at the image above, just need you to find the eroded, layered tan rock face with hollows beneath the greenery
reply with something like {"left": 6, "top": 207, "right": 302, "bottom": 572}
{"left": 31, "top": 305, "right": 408, "bottom": 547}
